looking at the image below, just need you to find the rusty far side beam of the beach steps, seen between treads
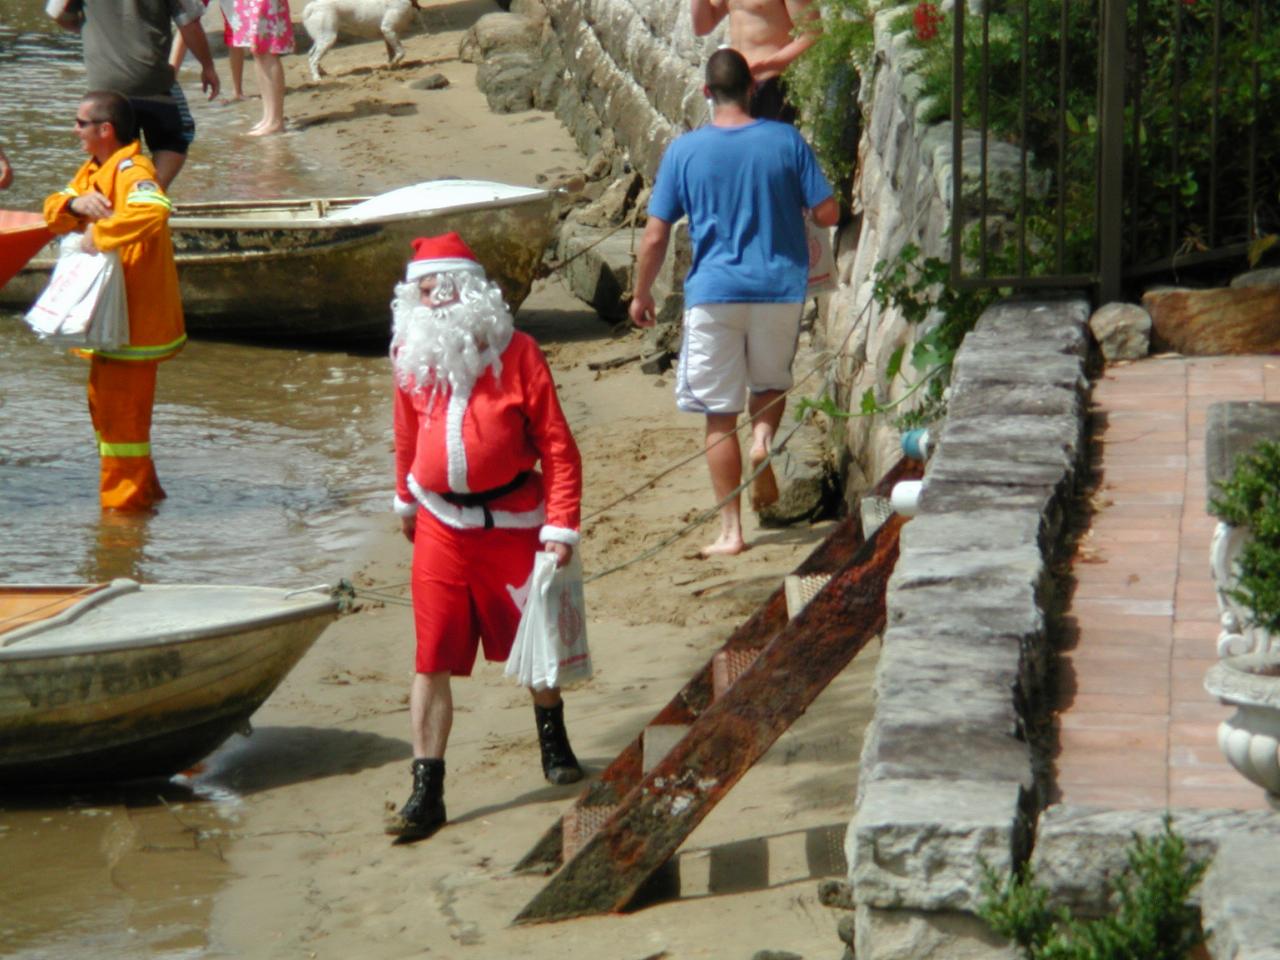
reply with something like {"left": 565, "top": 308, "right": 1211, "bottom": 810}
{"left": 513, "top": 458, "right": 923, "bottom": 874}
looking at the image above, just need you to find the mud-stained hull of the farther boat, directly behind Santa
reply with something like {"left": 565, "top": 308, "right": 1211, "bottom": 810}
{"left": 0, "top": 183, "right": 556, "bottom": 343}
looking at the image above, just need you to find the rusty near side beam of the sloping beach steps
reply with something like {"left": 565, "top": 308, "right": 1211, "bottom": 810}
{"left": 516, "top": 516, "right": 904, "bottom": 923}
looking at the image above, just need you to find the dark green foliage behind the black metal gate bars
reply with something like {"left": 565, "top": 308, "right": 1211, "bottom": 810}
{"left": 897, "top": 0, "right": 1280, "bottom": 273}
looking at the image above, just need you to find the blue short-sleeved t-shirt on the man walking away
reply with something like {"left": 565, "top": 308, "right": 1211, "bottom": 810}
{"left": 649, "top": 120, "right": 831, "bottom": 307}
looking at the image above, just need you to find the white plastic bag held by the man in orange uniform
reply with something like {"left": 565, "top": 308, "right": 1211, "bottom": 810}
{"left": 27, "top": 234, "right": 129, "bottom": 349}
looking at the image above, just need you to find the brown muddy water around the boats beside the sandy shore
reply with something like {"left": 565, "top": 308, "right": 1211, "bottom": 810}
{"left": 0, "top": 0, "right": 414, "bottom": 960}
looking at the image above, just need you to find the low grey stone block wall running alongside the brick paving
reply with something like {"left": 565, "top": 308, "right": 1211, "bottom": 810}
{"left": 845, "top": 298, "right": 1088, "bottom": 960}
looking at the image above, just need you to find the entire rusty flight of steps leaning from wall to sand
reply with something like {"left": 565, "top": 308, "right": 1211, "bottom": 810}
{"left": 504, "top": 461, "right": 920, "bottom": 923}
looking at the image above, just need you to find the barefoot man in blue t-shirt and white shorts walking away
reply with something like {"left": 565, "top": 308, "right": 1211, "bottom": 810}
{"left": 630, "top": 47, "right": 840, "bottom": 557}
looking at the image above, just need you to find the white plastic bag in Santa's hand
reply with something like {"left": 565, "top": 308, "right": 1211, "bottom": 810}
{"left": 503, "top": 550, "right": 591, "bottom": 690}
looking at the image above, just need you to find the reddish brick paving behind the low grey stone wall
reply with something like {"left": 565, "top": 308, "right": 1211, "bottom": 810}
{"left": 1055, "top": 356, "right": 1280, "bottom": 810}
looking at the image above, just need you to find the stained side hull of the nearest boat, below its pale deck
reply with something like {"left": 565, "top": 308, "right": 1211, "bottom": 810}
{"left": 0, "top": 583, "right": 335, "bottom": 788}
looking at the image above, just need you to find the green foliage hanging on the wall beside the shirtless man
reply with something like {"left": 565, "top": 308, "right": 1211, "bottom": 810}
{"left": 786, "top": 0, "right": 876, "bottom": 183}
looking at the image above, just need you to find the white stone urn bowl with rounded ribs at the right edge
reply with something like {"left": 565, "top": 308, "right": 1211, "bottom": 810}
{"left": 1204, "top": 652, "right": 1280, "bottom": 810}
